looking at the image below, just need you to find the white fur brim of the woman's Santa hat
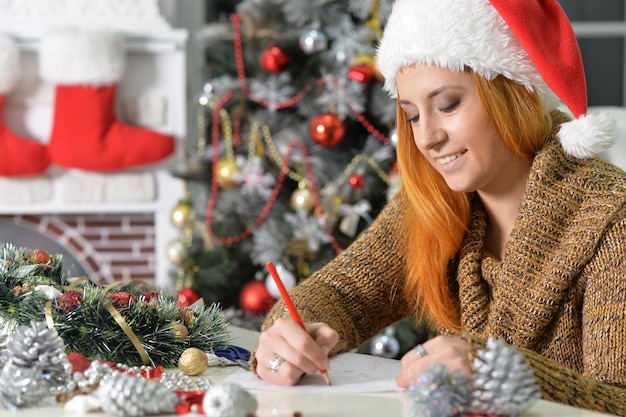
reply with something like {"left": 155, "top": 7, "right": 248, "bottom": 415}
{"left": 377, "top": 0, "right": 547, "bottom": 97}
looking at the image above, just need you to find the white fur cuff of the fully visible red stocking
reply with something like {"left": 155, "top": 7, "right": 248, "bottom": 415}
{"left": 40, "top": 29, "right": 125, "bottom": 85}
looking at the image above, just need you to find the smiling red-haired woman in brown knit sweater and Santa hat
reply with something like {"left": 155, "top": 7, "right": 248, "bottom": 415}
{"left": 253, "top": 0, "right": 626, "bottom": 415}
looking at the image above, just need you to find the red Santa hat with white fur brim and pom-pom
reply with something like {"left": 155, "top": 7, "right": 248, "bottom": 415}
{"left": 377, "top": 0, "right": 616, "bottom": 158}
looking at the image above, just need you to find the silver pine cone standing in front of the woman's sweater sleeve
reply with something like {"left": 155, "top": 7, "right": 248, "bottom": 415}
{"left": 472, "top": 338, "right": 540, "bottom": 416}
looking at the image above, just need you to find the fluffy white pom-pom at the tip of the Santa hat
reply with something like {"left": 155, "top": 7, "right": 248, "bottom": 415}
{"left": 558, "top": 112, "right": 617, "bottom": 159}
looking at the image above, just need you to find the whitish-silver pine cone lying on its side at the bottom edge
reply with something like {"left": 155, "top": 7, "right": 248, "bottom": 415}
{"left": 94, "top": 371, "right": 178, "bottom": 417}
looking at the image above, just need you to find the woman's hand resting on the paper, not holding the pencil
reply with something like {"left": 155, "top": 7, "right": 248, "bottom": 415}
{"left": 396, "top": 336, "right": 472, "bottom": 388}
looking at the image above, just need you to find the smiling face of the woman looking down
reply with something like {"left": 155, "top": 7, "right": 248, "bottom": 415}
{"left": 396, "top": 65, "right": 527, "bottom": 194}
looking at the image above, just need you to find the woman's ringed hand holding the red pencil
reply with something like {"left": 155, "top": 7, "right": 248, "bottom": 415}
{"left": 255, "top": 318, "right": 339, "bottom": 385}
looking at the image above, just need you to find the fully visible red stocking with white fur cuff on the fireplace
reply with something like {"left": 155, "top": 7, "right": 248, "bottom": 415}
{"left": 40, "top": 31, "right": 175, "bottom": 171}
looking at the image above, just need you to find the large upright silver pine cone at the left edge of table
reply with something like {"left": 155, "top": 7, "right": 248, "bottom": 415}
{"left": 0, "top": 321, "right": 72, "bottom": 410}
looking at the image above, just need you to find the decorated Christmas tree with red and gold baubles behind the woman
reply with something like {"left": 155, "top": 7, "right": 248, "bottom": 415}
{"left": 169, "top": 0, "right": 424, "bottom": 354}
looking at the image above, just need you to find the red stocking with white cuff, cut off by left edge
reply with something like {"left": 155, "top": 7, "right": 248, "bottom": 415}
{"left": 0, "top": 35, "right": 50, "bottom": 177}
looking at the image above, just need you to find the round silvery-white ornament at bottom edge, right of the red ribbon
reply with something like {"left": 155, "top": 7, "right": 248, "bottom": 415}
{"left": 202, "top": 384, "right": 257, "bottom": 417}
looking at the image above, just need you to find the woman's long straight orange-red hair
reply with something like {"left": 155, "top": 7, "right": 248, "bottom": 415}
{"left": 396, "top": 70, "right": 552, "bottom": 331}
